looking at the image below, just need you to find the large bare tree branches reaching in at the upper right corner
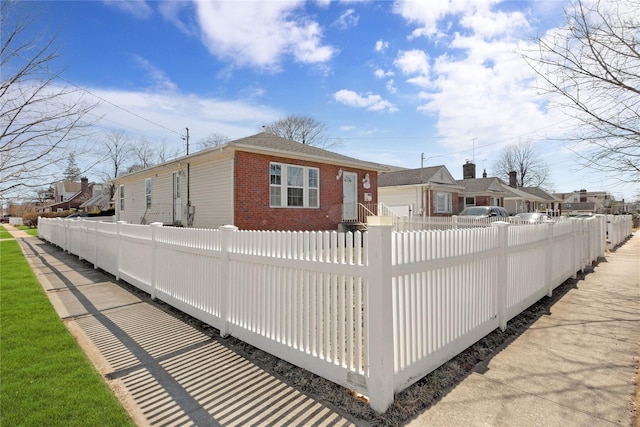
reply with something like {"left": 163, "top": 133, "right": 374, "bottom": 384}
{"left": 525, "top": 0, "right": 640, "bottom": 182}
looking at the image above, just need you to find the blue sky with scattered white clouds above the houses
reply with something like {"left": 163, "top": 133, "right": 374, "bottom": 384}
{"left": 33, "top": 0, "right": 637, "bottom": 199}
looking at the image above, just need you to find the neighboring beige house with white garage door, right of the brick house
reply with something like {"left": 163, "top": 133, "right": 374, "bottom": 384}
{"left": 378, "top": 165, "right": 463, "bottom": 217}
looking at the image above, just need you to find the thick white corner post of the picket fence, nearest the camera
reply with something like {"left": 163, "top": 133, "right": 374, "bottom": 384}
{"left": 365, "top": 217, "right": 395, "bottom": 413}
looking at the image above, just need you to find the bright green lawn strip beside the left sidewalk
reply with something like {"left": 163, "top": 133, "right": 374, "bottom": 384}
{"left": 0, "top": 240, "right": 135, "bottom": 426}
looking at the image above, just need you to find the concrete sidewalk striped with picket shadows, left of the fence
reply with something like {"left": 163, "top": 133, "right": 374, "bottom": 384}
{"left": 6, "top": 226, "right": 356, "bottom": 427}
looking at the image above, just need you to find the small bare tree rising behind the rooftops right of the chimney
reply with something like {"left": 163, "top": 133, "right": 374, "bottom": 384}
{"left": 493, "top": 141, "right": 549, "bottom": 187}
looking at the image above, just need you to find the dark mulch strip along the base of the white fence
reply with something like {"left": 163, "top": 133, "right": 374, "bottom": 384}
{"left": 121, "top": 276, "right": 581, "bottom": 426}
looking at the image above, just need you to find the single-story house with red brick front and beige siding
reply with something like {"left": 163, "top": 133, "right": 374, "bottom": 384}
{"left": 114, "top": 132, "right": 389, "bottom": 230}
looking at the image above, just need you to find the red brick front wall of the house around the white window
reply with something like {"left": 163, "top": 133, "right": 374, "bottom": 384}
{"left": 233, "top": 151, "right": 378, "bottom": 231}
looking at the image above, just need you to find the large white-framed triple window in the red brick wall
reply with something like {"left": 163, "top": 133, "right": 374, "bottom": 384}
{"left": 269, "top": 163, "right": 320, "bottom": 208}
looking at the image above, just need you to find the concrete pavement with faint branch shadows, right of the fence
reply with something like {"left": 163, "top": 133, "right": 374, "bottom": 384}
{"left": 408, "top": 233, "right": 640, "bottom": 427}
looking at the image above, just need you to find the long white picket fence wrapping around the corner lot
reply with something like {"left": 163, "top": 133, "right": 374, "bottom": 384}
{"left": 38, "top": 216, "right": 631, "bottom": 412}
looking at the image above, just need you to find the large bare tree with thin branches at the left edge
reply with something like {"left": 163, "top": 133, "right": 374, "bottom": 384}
{"left": 0, "top": 1, "right": 97, "bottom": 197}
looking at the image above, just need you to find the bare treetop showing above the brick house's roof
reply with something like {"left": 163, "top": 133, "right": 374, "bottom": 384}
{"left": 263, "top": 115, "right": 339, "bottom": 149}
